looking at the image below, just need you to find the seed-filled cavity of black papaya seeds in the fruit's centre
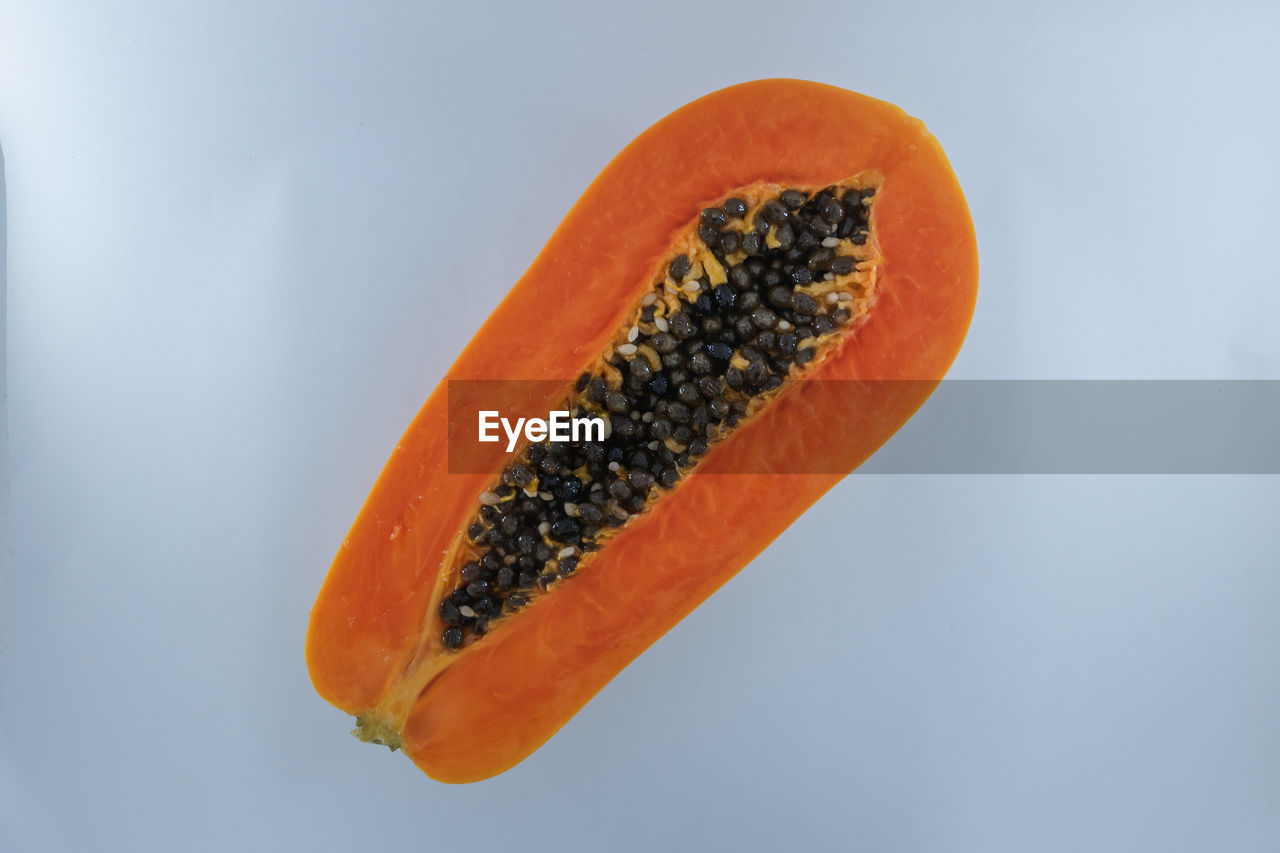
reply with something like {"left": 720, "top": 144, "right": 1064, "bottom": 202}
{"left": 438, "top": 174, "right": 879, "bottom": 651}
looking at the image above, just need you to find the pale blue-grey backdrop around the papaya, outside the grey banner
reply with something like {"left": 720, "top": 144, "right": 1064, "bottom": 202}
{"left": 0, "top": 0, "right": 1280, "bottom": 852}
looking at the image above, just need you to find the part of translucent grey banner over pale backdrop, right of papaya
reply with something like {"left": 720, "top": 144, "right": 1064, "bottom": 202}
{"left": 859, "top": 379, "right": 1280, "bottom": 474}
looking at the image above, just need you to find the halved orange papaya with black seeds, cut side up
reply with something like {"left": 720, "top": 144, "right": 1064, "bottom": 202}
{"left": 306, "top": 79, "right": 978, "bottom": 783}
